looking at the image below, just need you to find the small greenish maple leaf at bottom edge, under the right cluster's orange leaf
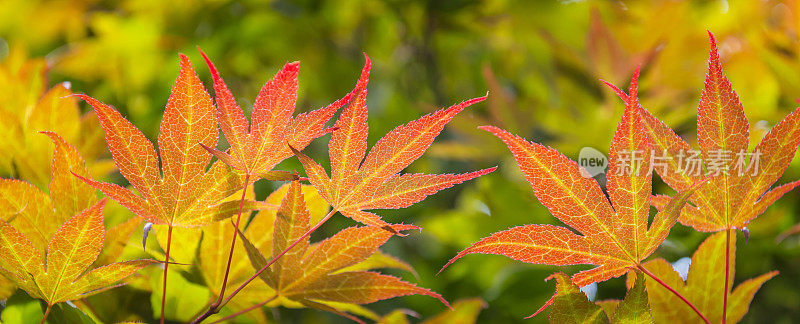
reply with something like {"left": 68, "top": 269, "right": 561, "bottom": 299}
{"left": 547, "top": 271, "right": 652, "bottom": 323}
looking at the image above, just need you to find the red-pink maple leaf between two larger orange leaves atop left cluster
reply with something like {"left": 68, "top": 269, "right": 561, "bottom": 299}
{"left": 200, "top": 51, "right": 360, "bottom": 180}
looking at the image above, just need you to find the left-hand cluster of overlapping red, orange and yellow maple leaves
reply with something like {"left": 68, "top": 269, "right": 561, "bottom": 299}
{"left": 0, "top": 42, "right": 494, "bottom": 322}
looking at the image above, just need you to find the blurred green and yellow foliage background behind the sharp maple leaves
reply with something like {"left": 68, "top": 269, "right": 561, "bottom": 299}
{"left": 0, "top": 0, "right": 800, "bottom": 323}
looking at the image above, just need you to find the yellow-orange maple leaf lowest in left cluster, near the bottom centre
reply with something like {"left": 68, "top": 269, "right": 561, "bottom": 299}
{"left": 239, "top": 181, "right": 448, "bottom": 316}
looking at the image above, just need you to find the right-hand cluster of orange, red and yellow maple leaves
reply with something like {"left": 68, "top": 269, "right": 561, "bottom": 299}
{"left": 445, "top": 33, "right": 800, "bottom": 323}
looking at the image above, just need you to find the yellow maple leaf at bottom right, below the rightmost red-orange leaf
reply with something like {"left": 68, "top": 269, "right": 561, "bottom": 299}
{"left": 628, "top": 232, "right": 778, "bottom": 323}
